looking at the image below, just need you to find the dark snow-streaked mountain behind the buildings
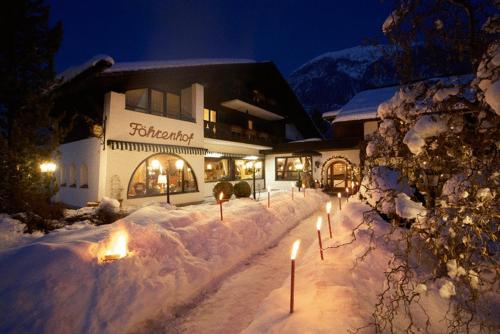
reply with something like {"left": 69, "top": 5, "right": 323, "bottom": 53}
{"left": 288, "top": 45, "right": 397, "bottom": 113}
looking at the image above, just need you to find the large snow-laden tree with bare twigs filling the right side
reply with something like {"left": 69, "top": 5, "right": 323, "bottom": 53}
{"left": 361, "top": 0, "right": 500, "bottom": 332}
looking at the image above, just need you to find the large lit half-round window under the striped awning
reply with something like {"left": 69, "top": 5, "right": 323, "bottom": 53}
{"left": 127, "top": 154, "right": 198, "bottom": 198}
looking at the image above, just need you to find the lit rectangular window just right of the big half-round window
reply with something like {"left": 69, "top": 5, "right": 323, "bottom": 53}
{"left": 205, "top": 158, "right": 264, "bottom": 182}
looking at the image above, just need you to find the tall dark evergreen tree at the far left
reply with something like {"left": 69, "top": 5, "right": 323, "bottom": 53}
{"left": 0, "top": 0, "right": 62, "bottom": 220}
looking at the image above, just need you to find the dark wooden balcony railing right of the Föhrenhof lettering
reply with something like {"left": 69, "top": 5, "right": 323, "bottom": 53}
{"left": 204, "top": 121, "right": 284, "bottom": 145}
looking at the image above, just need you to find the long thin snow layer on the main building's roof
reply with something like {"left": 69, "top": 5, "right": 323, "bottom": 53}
{"left": 104, "top": 58, "right": 256, "bottom": 73}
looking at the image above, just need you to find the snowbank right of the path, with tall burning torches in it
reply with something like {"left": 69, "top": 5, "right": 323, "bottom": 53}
{"left": 242, "top": 201, "right": 454, "bottom": 334}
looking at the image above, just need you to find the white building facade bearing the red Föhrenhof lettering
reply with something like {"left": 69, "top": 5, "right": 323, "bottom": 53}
{"left": 56, "top": 83, "right": 270, "bottom": 207}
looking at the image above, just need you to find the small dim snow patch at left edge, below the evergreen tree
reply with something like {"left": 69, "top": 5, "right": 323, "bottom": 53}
{"left": 0, "top": 214, "right": 43, "bottom": 251}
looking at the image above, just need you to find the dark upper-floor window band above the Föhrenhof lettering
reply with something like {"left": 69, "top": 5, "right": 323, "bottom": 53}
{"left": 125, "top": 88, "right": 189, "bottom": 121}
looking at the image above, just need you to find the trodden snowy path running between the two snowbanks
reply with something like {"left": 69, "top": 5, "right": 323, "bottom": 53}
{"left": 158, "top": 207, "right": 326, "bottom": 334}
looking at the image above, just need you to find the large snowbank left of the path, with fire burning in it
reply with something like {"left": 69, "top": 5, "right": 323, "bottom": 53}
{"left": 0, "top": 190, "right": 327, "bottom": 333}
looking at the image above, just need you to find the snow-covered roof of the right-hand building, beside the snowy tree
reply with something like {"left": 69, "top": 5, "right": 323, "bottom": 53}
{"left": 330, "top": 86, "right": 399, "bottom": 124}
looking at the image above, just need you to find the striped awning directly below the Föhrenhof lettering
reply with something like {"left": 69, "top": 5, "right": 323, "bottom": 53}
{"left": 107, "top": 139, "right": 208, "bottom": 155}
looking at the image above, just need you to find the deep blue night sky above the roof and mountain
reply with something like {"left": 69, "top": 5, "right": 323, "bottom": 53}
{"left": 48, "top": 0, "right": 392, "bottom": 76}
